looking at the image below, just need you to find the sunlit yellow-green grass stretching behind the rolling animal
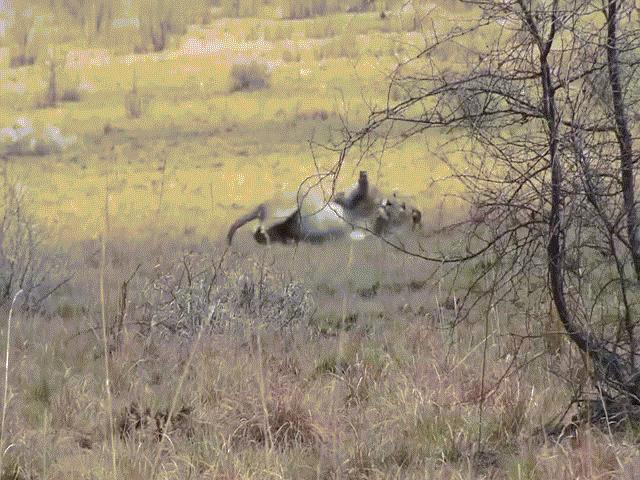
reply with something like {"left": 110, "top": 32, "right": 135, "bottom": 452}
{"left": 0, "top": 4, "right": 464, "bottom": 244}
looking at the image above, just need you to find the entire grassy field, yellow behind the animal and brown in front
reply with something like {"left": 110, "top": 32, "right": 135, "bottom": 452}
{"left": 0, "top": 2, "right": 640, "bottom": 480}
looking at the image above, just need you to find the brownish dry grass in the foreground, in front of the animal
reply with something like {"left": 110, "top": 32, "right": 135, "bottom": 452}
{"left": 2, "top": 233, "right": 640, "bottom": 479}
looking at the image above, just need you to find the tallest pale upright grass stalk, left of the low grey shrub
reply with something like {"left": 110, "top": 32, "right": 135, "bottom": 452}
{"left": 100, "top": 186, "right": 118, "bottom": 480}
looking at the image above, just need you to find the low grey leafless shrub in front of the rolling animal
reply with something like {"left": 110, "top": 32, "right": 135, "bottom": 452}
{"left": 142, "top": 253, "right": 314, "bottom": 336}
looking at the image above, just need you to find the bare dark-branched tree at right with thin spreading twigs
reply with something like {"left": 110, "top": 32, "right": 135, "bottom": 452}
{"left": 341, "top": 0, "right": 640, "bottom": 420}
